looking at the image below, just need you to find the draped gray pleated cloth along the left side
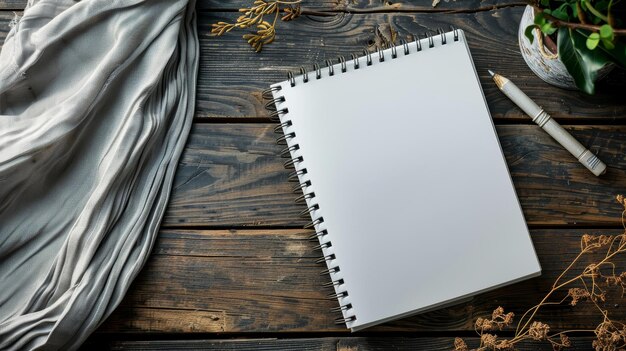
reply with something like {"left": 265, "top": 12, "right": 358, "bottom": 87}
{"left": 0, "top": 0, "right": 199, "bottom": 350}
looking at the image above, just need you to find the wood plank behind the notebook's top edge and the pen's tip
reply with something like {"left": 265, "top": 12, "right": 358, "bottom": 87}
{"left": 197, "top": 7, "right": 626, "bottom": 123}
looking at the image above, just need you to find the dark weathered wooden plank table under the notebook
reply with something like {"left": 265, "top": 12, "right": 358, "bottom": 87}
{"left": 0, "top": 0, "right": 626, "bottom": 350}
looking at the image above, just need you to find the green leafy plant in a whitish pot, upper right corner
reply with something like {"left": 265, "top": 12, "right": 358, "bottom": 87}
{"left": 519, "top": 0, "right": 626, "bottom": 94}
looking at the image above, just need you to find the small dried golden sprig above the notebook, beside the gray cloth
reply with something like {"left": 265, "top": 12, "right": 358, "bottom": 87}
{"left": 211, "top": 0, "right": 302, "bottom": 52}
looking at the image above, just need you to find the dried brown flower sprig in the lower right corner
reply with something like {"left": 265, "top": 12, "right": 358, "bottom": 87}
{"left": 454, "top": 195, "right": 626, "bottom": 351}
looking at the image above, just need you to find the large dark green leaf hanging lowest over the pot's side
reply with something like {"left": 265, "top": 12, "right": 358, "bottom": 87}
{"left": 558, "top": 27, "right": 609, "bottom": 94}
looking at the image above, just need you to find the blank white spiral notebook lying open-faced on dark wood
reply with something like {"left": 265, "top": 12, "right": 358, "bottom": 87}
{"left": 265, "top": 30, "right": 541, "bottom": 331}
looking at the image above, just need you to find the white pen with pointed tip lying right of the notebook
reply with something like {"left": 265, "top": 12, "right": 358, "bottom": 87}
{"left": 489, "top": 70, "right": 606, "bottom": 176}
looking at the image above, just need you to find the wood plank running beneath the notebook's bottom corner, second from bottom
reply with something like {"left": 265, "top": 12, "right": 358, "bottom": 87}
{"left": 99, "top": 229, "right": 626, "bottom": 334}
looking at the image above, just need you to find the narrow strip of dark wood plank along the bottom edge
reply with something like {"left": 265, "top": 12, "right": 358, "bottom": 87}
{"left": 82, "top": 336, "right": 593, "bottom": 351}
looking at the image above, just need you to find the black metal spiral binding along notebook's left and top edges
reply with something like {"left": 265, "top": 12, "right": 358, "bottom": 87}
{"left": 262, "top": 27, "right": 459, "bottom": 324}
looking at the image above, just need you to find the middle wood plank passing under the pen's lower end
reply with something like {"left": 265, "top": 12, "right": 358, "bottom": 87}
{"left": 164, "top": 124, "right": 626, "bottom": 226}
